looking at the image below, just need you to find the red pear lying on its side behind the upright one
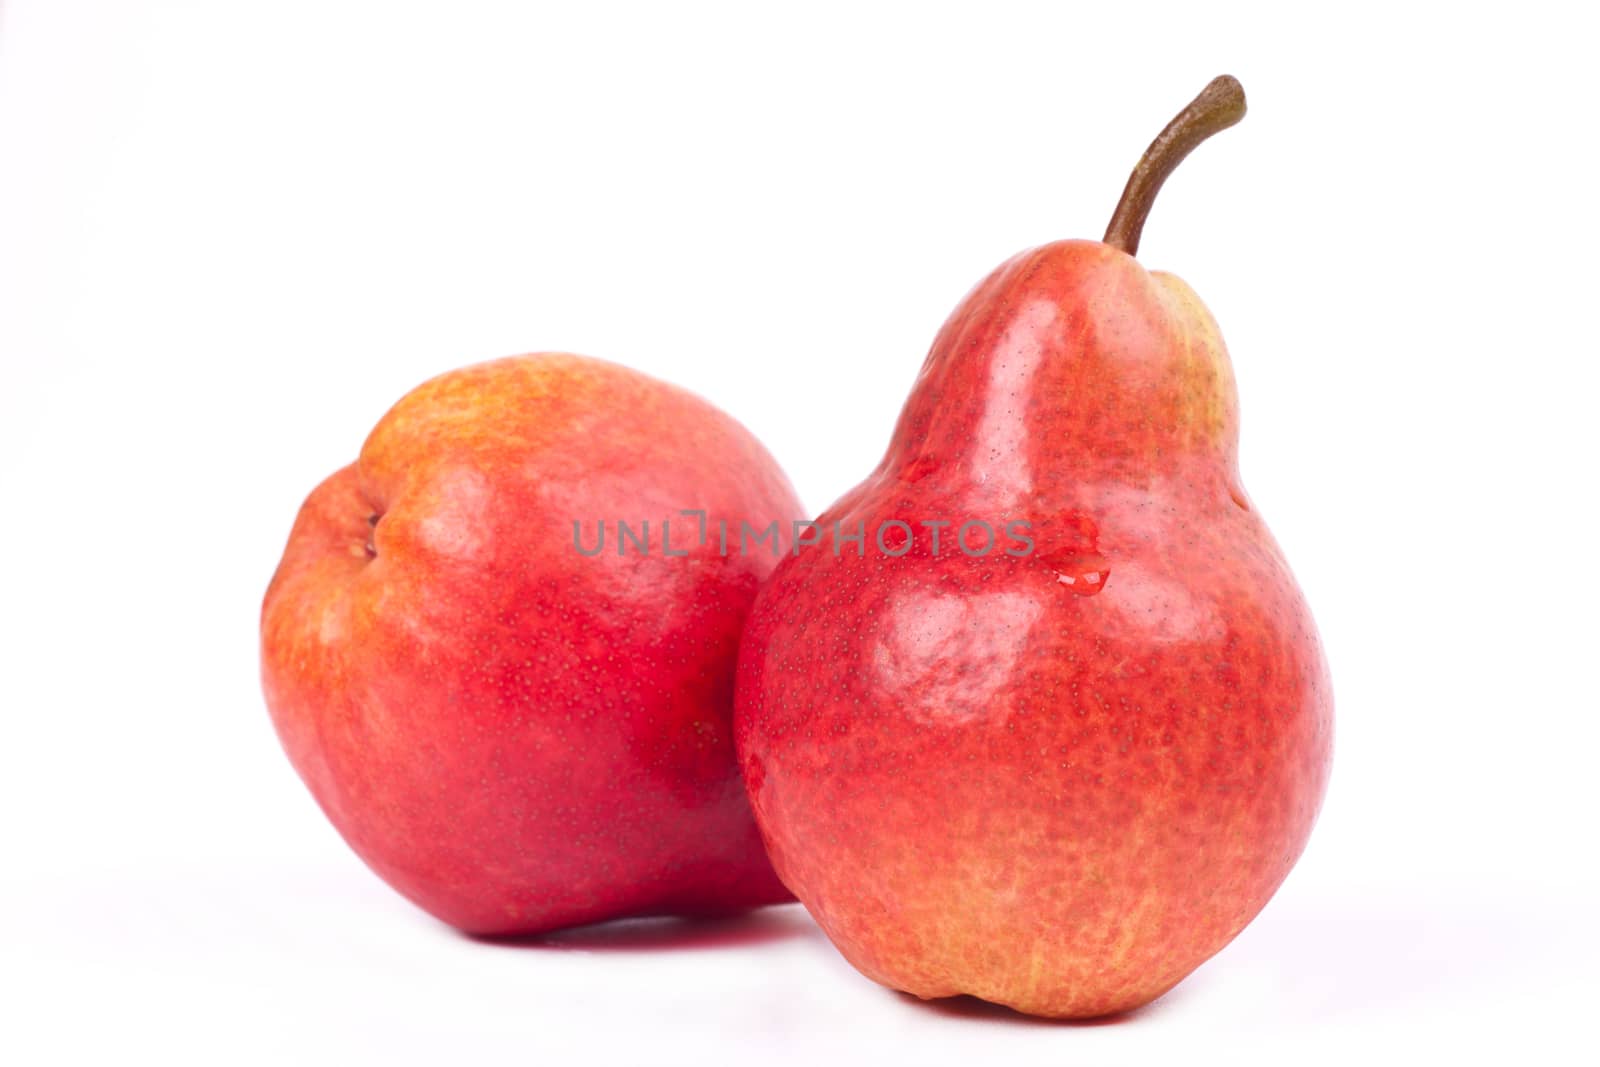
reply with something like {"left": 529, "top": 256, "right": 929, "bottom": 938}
{"left": 261, "top": 354, "right": 798, "bottom": 934}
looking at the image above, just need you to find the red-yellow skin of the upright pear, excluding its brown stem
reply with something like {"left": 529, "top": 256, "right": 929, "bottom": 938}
{"left": 734, "top": 242, "right": 1333, "bottom": 1017}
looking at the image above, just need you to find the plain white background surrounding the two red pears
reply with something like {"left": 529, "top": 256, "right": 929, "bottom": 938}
{"left": 0, "top": 0, "right": 1600, "bottom": 1064}
